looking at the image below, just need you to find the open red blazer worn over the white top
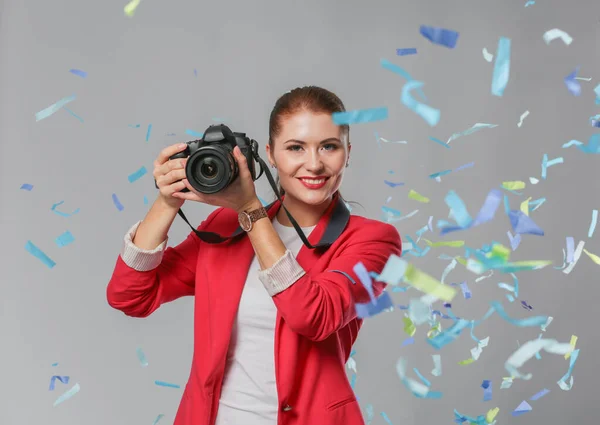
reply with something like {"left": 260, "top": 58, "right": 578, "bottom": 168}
{"left": 107, "top": 197, "right": 401, "bottom": 425}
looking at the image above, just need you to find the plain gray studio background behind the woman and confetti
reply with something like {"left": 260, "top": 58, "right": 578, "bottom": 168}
{"left": 0, "top": 0, "right": 600, "bottom": 425}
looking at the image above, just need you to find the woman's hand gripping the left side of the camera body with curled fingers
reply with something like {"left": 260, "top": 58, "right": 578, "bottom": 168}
{"left": 152, "top": 143, "right": 187, "bottom": 209}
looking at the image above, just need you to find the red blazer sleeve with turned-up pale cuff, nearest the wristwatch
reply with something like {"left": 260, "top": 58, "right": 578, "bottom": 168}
{"left": 259, "top": 221, "right": 402, "bottom": 341}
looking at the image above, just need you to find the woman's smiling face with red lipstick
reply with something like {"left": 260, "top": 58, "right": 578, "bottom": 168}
{"left": 266, "top": 111, "right": 350, "bottom": 205}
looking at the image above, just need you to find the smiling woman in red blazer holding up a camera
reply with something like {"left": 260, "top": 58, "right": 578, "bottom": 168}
{"left": 107, "top": 86, "right": 401, "bottom": 425}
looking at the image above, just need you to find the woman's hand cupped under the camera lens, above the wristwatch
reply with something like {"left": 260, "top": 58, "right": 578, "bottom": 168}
{"left": 172, "top": 146, "right": 258, "bottom": 212}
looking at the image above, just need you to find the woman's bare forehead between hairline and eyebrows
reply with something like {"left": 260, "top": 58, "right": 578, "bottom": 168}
{"left": 278, "top": 110, "right": 341, "bottom": 142}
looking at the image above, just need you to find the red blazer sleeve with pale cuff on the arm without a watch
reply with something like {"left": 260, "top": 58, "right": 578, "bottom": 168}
{"left": 106, "top": 210, "right": 219, "bottom": 317}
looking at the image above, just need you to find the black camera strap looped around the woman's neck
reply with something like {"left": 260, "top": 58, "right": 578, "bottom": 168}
{"left": 177, "top": 153, "right": 350, "bottom": 249}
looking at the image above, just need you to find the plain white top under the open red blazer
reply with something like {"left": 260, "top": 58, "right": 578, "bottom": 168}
{"left": 215, "top": 217, "right": 316, "bottom": 425}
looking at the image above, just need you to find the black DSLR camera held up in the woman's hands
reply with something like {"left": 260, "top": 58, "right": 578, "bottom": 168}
{"left": 169, "top": 124, "right": 264, "bottom": 194}
